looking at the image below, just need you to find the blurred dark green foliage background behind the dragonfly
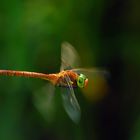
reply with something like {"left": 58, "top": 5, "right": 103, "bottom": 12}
{"left": 0, "top": 0, "right": 140, "bottom": 140}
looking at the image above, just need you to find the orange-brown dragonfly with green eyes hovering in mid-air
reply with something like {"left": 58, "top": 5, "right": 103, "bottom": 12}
{"left": 0, "top": 42, "right": 106, "bottom": 122}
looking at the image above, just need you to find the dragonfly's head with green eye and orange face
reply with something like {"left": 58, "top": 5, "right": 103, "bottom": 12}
{"left": 77, "top": 74, "right": 88, "bottom": 88}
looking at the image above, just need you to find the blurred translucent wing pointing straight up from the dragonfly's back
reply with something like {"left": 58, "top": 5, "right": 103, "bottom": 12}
{"left": 60, "top": 42, "right": 80, "bottom": 71}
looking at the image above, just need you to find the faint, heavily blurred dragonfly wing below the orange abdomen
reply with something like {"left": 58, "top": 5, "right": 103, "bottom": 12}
{"left": 33, "top": 84, "right": 55, "bottom": 122}
